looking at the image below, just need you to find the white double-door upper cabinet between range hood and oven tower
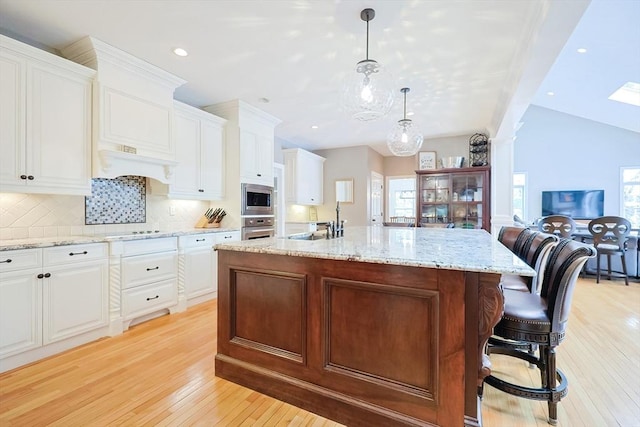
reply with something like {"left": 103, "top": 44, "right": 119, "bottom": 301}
{"left": 151, "top": 101, "right": 226, "bottom": 200}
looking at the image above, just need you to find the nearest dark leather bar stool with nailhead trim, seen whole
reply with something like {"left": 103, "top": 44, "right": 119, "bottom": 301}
{"left": 478, "top": 239, "right": 596, "bottom": 425}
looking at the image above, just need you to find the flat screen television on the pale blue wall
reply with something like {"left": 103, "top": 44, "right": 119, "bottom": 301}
{"left": 542, "top": 190, "right": 604, "bottom": 219}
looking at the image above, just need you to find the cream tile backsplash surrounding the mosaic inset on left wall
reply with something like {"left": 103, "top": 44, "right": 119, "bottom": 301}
{"left": 0, "top": 177, "right": 210, "bottom": 240}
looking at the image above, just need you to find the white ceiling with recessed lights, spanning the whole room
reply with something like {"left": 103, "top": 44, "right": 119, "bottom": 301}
{"left": 0, "top": 0, "right": 640, "bottom": 155}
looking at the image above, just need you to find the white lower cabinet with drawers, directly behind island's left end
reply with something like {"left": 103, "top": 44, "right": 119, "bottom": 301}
{"left": 179, "top": 231, "right": 240, "bottom": 306}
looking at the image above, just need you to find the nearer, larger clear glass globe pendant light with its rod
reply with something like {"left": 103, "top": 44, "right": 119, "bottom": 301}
{"left": 342, "top": 9, "right": 395, "bottom": 121}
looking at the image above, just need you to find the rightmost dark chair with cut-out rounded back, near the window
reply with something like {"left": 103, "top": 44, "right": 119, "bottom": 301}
{"left": 588, "top": 216, "right": 631, "bottom": 286}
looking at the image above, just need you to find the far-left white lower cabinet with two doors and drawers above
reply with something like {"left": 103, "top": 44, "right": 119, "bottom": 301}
{"left": 0, "top": 243, "right": 109, "bottom": 372}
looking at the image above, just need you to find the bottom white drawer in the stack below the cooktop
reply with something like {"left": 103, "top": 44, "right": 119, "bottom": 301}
{"left": 122, "top": 279, "right": 178, "bottom": 320}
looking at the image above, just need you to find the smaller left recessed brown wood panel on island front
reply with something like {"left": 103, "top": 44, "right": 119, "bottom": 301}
{"left": 230, "top": 268, "right": 306, "bottom": 363}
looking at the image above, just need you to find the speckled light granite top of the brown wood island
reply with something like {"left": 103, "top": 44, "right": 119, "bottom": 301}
{"left": 215, "top": 227, "right": 535, "bottom": 276}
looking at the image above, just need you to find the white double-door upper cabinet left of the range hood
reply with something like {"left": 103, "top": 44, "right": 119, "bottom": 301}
{"left": 0, "top": 35, "right": 95, "bottom": 195}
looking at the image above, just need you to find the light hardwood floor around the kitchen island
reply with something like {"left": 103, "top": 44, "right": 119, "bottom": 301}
{"left": 0, "top": 279, "right": 640, "bottom": 427}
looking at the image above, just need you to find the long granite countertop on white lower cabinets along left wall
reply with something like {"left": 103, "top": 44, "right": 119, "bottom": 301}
{"left": 0, "top": 228, "right": 239, "bottom": 251}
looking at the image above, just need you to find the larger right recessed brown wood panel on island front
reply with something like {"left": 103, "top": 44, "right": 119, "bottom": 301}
{"left": 322, "top": 278, "right": 439, "bottom": 400}
